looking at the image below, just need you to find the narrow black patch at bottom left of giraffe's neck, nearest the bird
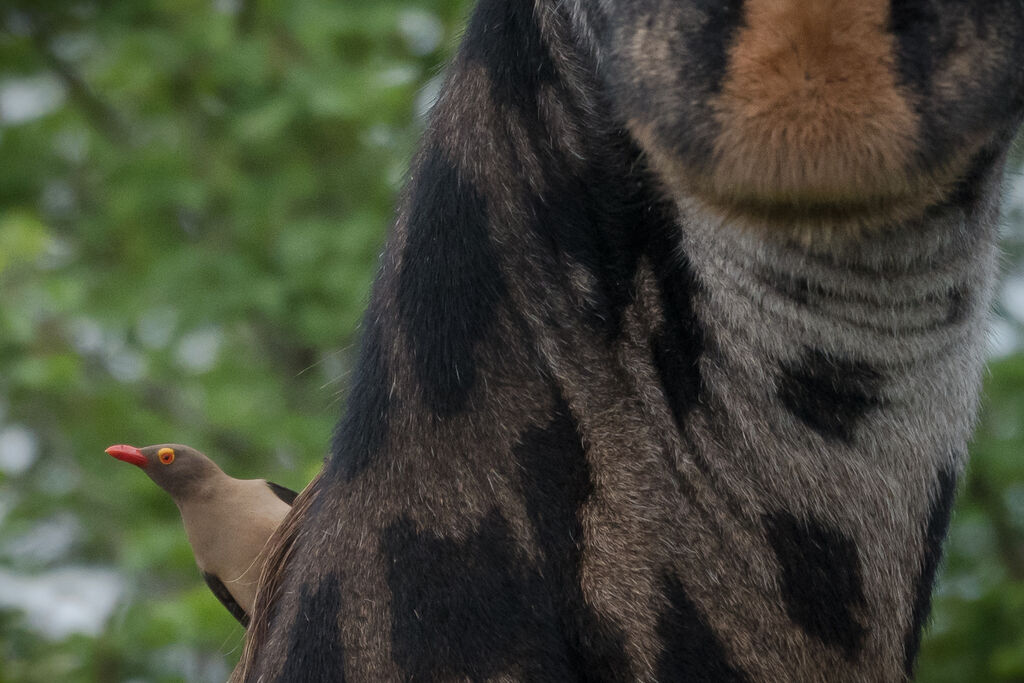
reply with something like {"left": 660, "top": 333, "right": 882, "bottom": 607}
{"left": 275, "top": 573, "right": 345, "bottom": 683}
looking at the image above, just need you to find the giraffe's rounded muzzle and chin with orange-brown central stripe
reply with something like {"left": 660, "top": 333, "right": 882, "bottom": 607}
{"left": 606, "top": 0, "right": 1024, "bottom": 232}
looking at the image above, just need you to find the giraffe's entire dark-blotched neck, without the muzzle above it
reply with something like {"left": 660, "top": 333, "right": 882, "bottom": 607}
{"left": 232, "top": 0, "right": 1015, "bottom": 682}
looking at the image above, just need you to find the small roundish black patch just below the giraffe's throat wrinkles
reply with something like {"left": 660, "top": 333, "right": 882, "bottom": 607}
{"left": 777, "top": 349, "right": 885, "bottom": 443}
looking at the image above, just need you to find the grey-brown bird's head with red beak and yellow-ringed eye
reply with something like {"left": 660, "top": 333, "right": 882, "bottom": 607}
{"left": 106, "top": 443, "right": 221, "bottom": 501}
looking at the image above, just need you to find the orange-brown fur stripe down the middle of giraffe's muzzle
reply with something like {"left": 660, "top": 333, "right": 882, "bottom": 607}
{"left": 710, "top": 0, "right": 918, "bottom": 203}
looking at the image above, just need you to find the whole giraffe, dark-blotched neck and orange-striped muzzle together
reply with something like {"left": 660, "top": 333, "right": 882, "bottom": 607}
{"left": 233, "top": 0, "right": 1024, "bottom": 683}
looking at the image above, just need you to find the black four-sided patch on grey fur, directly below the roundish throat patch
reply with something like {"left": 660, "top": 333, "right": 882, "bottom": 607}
{"left": 764, "top": 512, "right": 866, "bottom": 661}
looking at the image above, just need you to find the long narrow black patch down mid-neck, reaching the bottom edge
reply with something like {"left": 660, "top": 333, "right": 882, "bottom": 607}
{"left": 513, "top": 396, "right": 636, "bottom": 683}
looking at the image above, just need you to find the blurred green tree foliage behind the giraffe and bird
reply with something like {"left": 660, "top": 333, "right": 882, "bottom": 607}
{"left": 0, "top": 0, "right": 1024, "bottom": 683}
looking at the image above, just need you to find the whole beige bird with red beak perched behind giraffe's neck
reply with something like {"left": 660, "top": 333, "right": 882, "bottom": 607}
{"left": 105, "top": 443, "right": 298, "bottom": 628}
